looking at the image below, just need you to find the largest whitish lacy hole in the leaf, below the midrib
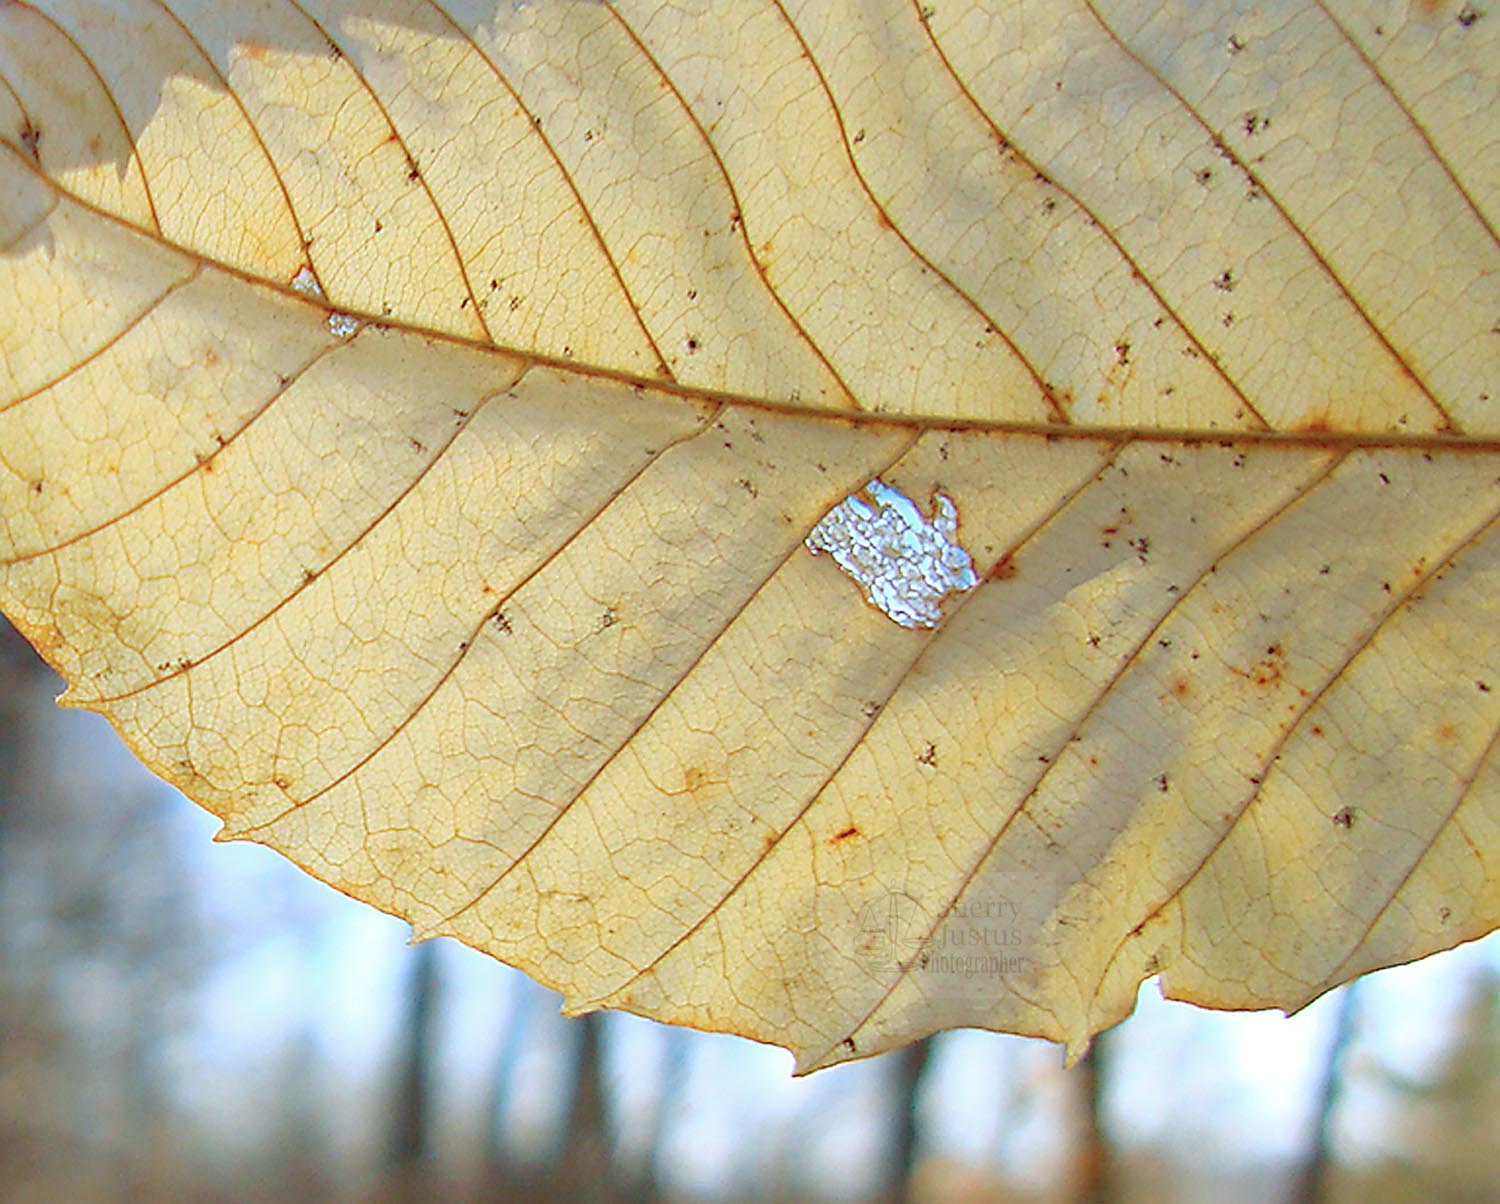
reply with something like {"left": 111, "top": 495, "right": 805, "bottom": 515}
{"left": 807, "top": 477, "right": 980, "bottom": 627}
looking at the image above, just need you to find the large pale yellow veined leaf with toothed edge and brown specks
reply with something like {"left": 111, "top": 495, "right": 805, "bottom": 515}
{"left": 0, "top": 0, "right": 1500, "bottom": 1069}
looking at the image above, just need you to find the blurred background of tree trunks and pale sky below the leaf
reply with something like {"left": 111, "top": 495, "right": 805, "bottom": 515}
{"left": 0, "top": 619, "right": 1500, "bottom": 1204}
